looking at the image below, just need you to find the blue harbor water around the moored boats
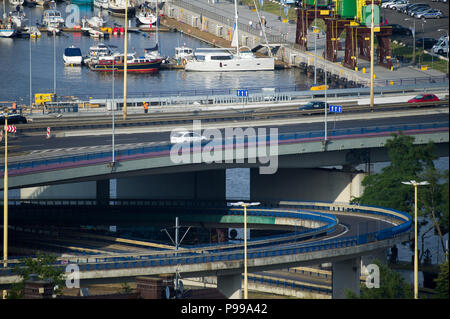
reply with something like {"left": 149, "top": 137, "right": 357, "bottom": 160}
{"left": 0, "top": 3, "right": 311, "bottom": 104}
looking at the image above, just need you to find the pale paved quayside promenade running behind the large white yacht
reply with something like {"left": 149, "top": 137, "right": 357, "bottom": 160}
{"left": 172, "top": 0, "right": 445, "bottom": 81}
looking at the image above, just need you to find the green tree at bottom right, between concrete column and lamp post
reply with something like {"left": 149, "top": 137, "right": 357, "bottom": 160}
{"left": 346, "top": 260, "right": 413, "bottom": 299}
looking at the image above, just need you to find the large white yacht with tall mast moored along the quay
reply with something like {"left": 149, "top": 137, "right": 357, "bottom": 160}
{"left": 184, "top": 0, "right": 275, "bottom": 72}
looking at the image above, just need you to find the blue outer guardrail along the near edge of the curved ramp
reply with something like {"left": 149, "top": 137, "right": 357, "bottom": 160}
{"left": 0, "top": 202, "right": 412, "bottom": 289}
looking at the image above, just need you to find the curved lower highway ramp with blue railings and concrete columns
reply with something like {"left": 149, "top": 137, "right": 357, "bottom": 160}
{"left": 0, "top": 201, "right": 411, "bottom": 298}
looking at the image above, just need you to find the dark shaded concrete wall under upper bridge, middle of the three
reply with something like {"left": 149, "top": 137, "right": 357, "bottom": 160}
{"left": 117, "top": 170, "right": 225, "bottom": 200}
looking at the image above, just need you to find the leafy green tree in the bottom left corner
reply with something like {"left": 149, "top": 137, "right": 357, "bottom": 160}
{"left": 8, "top": 252, "right": 65, "bottom": 299}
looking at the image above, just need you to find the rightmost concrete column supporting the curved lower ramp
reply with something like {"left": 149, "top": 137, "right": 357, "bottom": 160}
{"left": 332, "top": 257, "right": 361, "bottom": 299}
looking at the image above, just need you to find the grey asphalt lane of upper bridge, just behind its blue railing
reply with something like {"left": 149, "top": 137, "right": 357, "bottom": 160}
{"left": 8, "top": 110, "right": 448, "bottom": 152}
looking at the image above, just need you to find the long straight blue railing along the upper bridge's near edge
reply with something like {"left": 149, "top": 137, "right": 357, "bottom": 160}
{"left": 0, "top": 121, "right": 449, "bottom": 176}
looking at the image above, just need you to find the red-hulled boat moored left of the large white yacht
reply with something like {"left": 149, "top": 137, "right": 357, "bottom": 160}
{"left": 88, "top": 53, "right": 162, "bottom": 73}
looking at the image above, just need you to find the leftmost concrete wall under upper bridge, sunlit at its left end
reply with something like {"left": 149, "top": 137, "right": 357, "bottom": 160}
{"left": 20, "top": 182, "right": 97, "bottom": 199}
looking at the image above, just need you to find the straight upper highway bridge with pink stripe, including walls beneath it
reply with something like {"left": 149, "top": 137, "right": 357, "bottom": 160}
{"left": 0, "top": 106, "right": 449, "bottom": 202}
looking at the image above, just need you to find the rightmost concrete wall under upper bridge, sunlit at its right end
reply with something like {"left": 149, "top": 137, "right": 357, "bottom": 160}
{"left": 250, "top": 168, "right": 365, "bottom": 202}
